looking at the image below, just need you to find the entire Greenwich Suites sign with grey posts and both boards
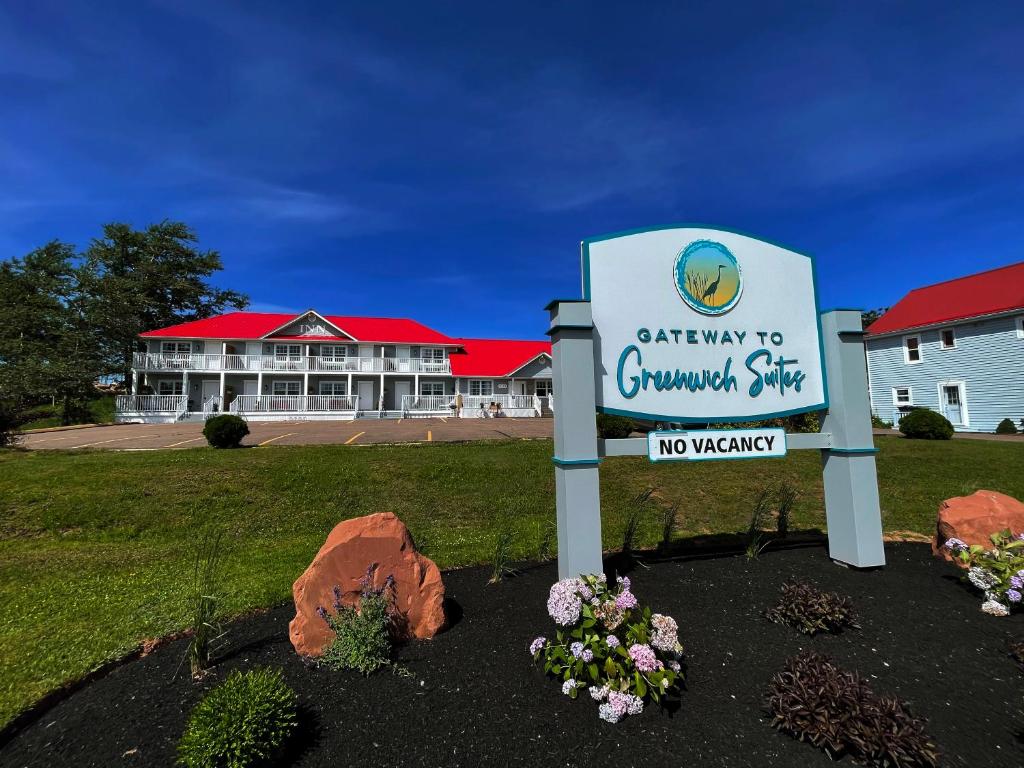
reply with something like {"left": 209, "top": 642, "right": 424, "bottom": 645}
{"left": 548, "top": 226, "right": 885, "bottom": 579}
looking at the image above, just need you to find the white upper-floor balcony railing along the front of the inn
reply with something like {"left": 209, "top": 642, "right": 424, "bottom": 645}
{"left": 133, "top": 352, "right": 452, "bottom": 374}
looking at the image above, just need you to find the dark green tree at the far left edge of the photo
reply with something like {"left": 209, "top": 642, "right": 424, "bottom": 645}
{"left": 0, "top": 241, "right": 102, "bottom": 423}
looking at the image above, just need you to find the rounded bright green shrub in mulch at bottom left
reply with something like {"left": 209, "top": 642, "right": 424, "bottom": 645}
{"left": 178, "top": 669, "right": 298, "bottom": 768}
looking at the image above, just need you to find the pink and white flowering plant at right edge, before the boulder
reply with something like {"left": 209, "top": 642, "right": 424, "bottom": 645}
{"left": 944, "top": 529, "right": 1024, "bottom": 616}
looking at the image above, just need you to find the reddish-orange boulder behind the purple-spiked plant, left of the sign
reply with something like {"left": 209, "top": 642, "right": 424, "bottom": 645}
{"left": 289, "top": 512, "right": 444, "bottom": 656}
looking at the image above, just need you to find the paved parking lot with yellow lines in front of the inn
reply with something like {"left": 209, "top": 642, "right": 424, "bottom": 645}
{"left": 20, "top": 419, "right": 553, "bottom": 451}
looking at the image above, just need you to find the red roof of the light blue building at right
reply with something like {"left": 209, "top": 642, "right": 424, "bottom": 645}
{"left": 867, "top": 261, "right": 1024, "bottom": 336}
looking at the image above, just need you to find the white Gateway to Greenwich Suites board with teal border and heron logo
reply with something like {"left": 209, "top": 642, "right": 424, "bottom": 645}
{"left": 583, "top": 226, "right": 828, "bottom": 423}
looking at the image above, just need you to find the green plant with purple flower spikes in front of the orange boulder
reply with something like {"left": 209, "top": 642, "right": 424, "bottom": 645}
{"left": 317, "top": 566, "right": 396, "bottom": 675}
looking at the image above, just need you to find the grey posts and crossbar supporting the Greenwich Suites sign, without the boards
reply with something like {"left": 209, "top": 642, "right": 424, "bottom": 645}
{"left": 547, "top": 301, "right": 885, "bottom": 579}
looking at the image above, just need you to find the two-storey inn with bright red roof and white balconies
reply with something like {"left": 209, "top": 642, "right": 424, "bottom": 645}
{"left": 117, "top": 309, "right": 553, "bottom": 423}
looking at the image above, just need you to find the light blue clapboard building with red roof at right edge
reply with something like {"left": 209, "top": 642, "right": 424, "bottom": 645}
{"left": 865, "top": 262, "right": 1024, "bottom": 432}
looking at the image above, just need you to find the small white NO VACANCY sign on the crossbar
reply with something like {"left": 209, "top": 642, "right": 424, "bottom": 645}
{"left": 647, "top": 429, "right": 785, "bottom": 462}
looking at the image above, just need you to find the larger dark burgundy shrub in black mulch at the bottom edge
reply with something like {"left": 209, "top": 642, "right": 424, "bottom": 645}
{"left": 766, "top": 650, "right": 939, "bottom": 768}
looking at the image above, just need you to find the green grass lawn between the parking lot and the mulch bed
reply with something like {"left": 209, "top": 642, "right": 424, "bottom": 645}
{"left": 0, "top": 438, "right": 1024, "bottom": 724}
